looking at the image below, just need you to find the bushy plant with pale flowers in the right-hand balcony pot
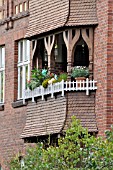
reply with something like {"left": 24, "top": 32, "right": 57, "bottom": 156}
{"left": 71, "top": 66, "right": 89, "bottom": 78}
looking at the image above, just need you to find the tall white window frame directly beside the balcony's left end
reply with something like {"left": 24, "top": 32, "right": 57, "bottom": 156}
{"left": 17, "top": 39, "right": 30, "bottom": 100}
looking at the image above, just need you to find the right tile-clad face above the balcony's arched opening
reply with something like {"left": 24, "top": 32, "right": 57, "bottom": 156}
{"left": 66, "top": 0, "right": 98, "bottom": 26}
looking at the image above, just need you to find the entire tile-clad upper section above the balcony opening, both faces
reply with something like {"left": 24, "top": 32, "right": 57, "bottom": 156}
{"left": 26, "top": 0, "right": 98, "bottom": 37}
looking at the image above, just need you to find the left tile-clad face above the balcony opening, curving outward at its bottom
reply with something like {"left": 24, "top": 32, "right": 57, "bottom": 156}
{"left": 26, "top": 0, "right": 69, "bottom": 37}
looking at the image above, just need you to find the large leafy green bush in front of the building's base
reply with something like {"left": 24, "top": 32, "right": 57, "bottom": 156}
{"left": 11, "top": 118, "right": 113, "bottom": 170}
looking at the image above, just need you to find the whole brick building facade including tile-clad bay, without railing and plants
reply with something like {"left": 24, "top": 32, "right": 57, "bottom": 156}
{"left": 0, "top": 0, "right": 113, "bottom": 170}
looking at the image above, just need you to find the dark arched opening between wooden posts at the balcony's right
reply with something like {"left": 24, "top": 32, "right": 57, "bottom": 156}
{"left": 74, "top": 36, "right": 89, "bottom": 67}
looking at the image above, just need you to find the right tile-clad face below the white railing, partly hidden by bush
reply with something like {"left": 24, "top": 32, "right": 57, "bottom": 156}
{"left": 64, "top": 92, "right": 98, "bottom": 132}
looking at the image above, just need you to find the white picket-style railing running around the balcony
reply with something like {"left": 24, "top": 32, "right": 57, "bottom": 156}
{"left": 23, "top": 78, "right": 97, "bottom": 103}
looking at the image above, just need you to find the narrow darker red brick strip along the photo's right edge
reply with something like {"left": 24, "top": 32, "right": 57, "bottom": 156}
{"left": 107, "top": 0, "right": 113, "bottom": 128}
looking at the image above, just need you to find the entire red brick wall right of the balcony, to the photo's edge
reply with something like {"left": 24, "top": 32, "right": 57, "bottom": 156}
{"left": 94, "top": 0, "right": 113, "bottom": 135}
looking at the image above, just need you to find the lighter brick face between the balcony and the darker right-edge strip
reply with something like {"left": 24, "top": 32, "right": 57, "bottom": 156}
{"left": 94, "top": 0, "right": 108, "bottom": 135}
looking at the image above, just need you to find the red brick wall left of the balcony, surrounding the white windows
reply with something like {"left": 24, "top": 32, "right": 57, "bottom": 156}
{"left": 0, "top": 11, "right": 28, "bottom": 170}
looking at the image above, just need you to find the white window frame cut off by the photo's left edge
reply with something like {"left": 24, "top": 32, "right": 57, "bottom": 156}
{"left": 0, "top": 46, "right": 5, "bottom": 104}
